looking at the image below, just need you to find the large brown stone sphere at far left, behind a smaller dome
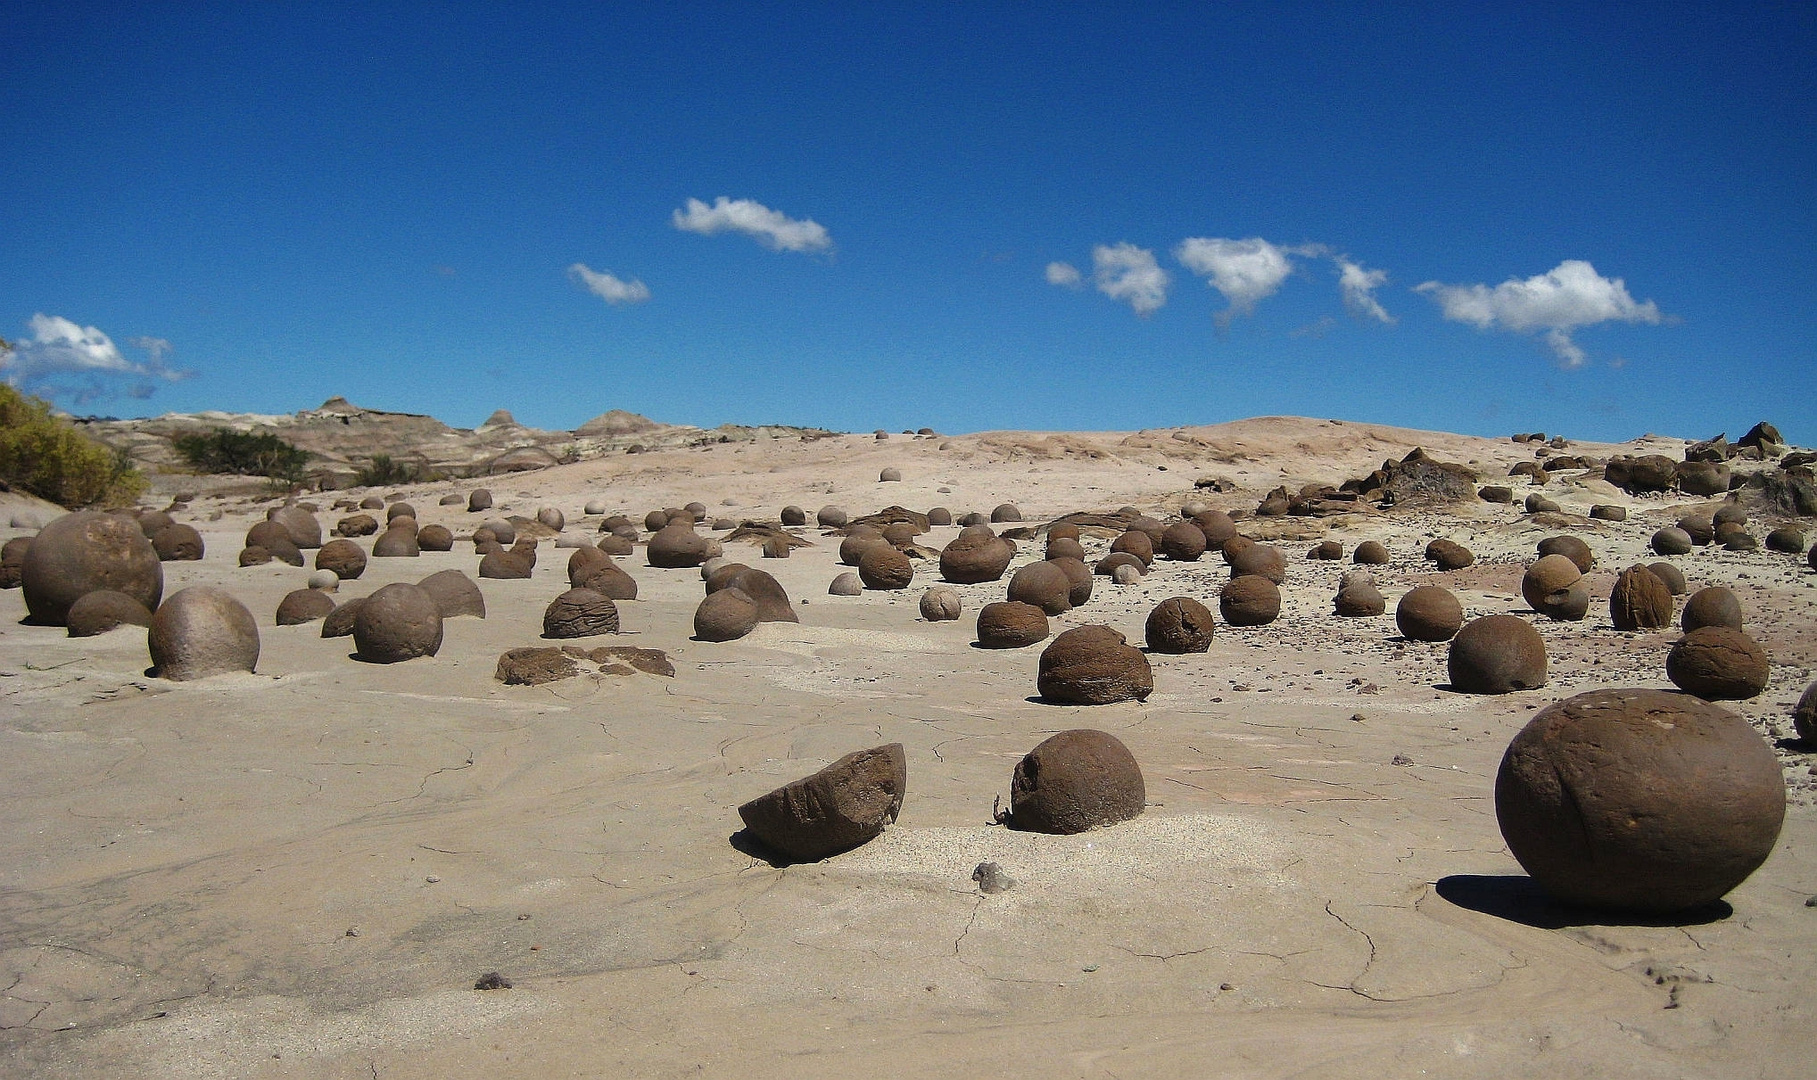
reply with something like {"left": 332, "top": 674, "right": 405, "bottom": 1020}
{"left": 20, "top": 511, "right": 164, "bottom": 625}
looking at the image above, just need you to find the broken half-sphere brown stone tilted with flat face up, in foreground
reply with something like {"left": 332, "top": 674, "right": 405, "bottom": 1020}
{"left": 738, "top": 742, "right": 909, "bottom": 862}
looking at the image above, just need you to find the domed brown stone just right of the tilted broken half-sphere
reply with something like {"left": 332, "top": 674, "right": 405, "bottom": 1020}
{"left": 1007, "top": 729, "right": 1147, "bottom": 835}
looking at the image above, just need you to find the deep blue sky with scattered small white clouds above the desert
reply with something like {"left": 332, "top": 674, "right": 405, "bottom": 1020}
{"left": 0, "top": 0, "right": 1817, "bottom": 444}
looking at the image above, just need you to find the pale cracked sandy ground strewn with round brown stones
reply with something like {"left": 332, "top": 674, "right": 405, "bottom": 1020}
{"left": 0, "top": 418, "right": 1817, "bottom": 1080}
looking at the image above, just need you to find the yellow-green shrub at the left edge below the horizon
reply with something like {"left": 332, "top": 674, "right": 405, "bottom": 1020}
{"left": 0, "top": 384, "right": 145, "bottom": 507}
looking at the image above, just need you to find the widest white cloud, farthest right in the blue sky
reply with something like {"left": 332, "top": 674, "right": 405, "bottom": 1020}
{"left": 1414, "top": 258, "right": 1666, "bottom": 367}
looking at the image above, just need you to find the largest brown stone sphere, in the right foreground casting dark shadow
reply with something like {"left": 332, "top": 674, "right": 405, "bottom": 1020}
{"left": 1495, "top": 689, "right": 1786, "bottom": 915}
